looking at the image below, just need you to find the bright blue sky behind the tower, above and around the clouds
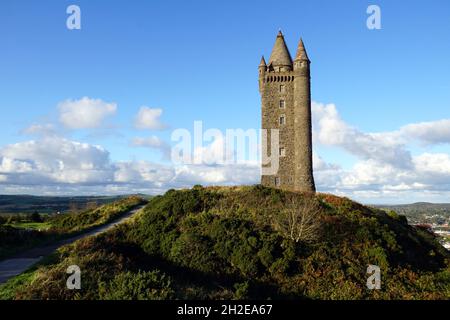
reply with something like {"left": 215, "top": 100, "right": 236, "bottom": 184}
{"left": 0, "top": 0, "right": 450, "bottom": 202}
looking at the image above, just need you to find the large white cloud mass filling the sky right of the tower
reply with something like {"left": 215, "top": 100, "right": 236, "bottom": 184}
{"left": 312, "top": 102, "right": 450, "bottom": 202}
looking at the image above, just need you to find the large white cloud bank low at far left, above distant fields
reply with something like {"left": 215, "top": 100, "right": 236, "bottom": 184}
{"left": 0, "top": 137, "right": 112, "bottom": 185}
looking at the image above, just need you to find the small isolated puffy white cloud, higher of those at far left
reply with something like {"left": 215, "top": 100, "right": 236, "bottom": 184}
{"left": 58, "top": 97, "right": 117, "bottom": 129}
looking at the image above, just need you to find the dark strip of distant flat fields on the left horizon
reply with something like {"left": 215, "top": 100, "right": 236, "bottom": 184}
{"left": 0, "top": 195, "right": 123, "bottom": 215}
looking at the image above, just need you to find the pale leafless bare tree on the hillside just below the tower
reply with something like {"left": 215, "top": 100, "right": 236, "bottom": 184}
{"left": 276, "top": 197, "right": 322, "bottom": 242}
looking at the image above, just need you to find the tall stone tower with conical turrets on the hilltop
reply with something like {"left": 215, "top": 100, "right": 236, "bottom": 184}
{"left": 258, "top": 31, "right": 315, "bottom": 192}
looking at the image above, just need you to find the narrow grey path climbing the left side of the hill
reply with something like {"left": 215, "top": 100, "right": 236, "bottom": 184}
{"left": 0, "top": 206, "right": 144, "bottom": 284}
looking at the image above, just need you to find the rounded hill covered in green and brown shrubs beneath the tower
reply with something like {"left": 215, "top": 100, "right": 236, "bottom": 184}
{"left": 0, "top": 186, "right": 450, "bottom": 299}
